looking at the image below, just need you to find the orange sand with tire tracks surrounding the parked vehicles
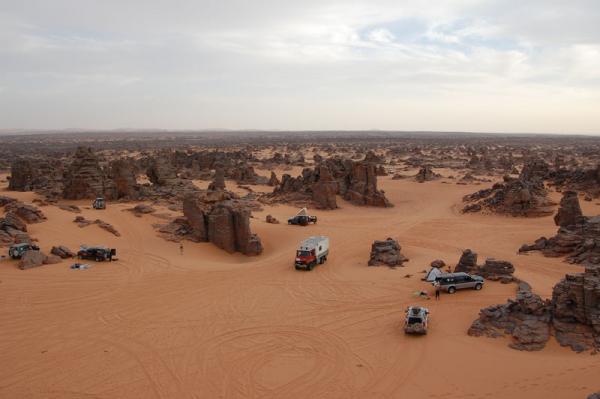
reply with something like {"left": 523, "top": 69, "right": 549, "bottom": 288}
{"left": 0, "top": 173, "right": 600, "bottom": 399}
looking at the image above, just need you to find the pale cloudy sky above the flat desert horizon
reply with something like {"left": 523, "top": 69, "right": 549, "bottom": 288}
{"left": 0, "top": 0, "right": 600, "bottom": 133}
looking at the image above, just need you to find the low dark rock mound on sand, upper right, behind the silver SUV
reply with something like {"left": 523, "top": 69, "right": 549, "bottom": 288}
{"left": 462, "top": 176, "right": 554, "bottom": 216}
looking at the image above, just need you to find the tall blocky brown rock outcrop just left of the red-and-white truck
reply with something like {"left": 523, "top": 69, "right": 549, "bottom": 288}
{"left": 159, "top": 191, "right": 263, "bottom": 255}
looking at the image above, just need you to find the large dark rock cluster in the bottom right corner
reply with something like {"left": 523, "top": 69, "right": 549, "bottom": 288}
{"left": 469, "top": 266, "right": 600, "bottom": 352}
